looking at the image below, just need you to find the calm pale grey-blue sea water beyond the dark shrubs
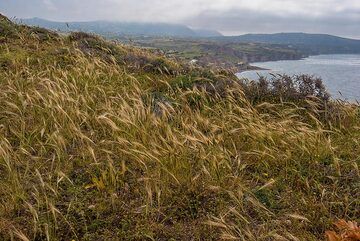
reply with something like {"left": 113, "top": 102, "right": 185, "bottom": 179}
{"left": 238, "top": 54, "right": 360, "bottom": 101}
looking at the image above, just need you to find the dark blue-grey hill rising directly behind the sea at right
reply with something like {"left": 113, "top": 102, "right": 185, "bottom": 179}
{"left": 217, "top": 33, "right": 360, "bottom": 55}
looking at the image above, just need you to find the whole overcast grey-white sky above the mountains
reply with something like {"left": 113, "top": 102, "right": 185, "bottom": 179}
{"left": 0, "top": 0, "right": 360, "bottom": 38}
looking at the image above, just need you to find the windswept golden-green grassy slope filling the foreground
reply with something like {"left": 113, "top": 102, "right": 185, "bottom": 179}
{"left": 0, "top": 15, "right": 360, "bottom": 240}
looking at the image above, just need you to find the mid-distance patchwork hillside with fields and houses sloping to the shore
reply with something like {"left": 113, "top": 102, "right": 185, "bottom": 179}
{"left": 122, "top": 37, "right": 307, "bottom": 69}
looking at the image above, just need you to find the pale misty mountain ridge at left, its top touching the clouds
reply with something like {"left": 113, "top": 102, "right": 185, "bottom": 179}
{"left": 20, "top": 18, "right": 222, "bottom": 37}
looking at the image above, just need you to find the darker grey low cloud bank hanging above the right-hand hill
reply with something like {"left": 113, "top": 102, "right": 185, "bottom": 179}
{"left": 187, "top": 9, "right": 360, "bottom": 38}
